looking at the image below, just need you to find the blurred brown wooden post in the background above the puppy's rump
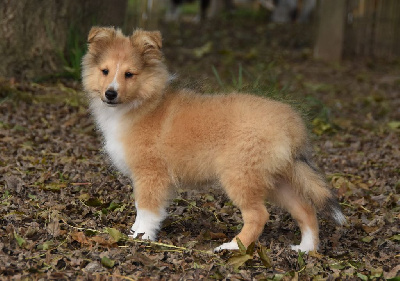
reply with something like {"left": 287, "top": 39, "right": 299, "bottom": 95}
{"left": 314, "top": 0, "right": 346, "bottom": 61}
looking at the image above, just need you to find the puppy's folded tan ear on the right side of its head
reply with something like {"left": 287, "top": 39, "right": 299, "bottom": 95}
{"left": 130, "top": 29, "right": 162, "bottom": 63}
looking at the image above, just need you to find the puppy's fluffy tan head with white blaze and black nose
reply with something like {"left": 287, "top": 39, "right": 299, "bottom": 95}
{"left": 82, "top": 27, "right": 168, "bottom": 106}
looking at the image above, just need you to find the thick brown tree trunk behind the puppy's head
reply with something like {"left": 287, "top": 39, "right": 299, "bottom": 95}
{"left": 0, "top": 0, "right": 127, "bottom": 79}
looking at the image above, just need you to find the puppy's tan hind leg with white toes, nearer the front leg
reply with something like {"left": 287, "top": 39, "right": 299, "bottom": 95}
{"left": 214, "top": 172, "right": 269, "bottom": 251}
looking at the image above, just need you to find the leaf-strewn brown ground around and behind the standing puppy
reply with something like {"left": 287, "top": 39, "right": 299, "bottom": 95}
{"left": 0, "top": 13, "right": 400, "bottom": 280}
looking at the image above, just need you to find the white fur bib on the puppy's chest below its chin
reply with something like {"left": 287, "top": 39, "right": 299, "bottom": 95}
{"left": 91, "top": 100, "right": 131, "bottom": 176}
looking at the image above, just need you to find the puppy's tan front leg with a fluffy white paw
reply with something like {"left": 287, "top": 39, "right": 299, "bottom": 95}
{"left": 129, "top": 165, "right": 170, "bottom": 241}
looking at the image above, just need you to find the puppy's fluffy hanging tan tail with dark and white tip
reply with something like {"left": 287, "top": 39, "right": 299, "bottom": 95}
{"left": 292, "top": 155, "right": 346, "bottom": 225}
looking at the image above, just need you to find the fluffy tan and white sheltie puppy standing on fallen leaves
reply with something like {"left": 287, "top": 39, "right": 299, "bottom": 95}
{"left": 82, "top": 27, "right": 345, "bottom": 252}
